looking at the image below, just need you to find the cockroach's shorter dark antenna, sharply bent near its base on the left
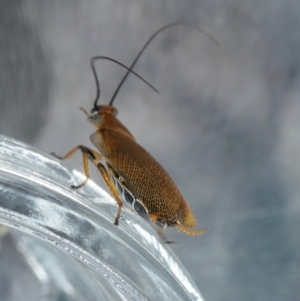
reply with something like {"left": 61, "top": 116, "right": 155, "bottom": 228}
{"left": 90, "top": 56, "right": 159, "bottom": 113}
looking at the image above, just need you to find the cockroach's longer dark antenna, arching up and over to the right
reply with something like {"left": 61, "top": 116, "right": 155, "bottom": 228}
{"left": 108, "top": 22, "right": 219, "bottom": 106}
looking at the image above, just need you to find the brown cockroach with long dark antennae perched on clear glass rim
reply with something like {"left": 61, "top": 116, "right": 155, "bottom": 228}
{"left": 53, "top": 23, "right": 215, "bottom": 236}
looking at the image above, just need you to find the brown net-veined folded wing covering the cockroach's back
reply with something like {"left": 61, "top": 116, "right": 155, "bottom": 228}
{"left": 96, "top": 129, "right": 184, "bottom": 219}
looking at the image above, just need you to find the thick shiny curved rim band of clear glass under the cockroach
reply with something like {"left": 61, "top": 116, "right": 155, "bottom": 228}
{"left": 0, "top": 135, "right": 203, "bottom": 301}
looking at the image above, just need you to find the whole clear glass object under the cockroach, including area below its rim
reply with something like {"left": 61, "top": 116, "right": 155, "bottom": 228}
{"left": 0, "top": 136, "right": 203, "bottom": 301}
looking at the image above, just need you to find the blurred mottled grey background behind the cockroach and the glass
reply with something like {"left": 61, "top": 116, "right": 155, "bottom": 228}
{"left": 0, "top": 0, "right": 300, "bottom": 301}
